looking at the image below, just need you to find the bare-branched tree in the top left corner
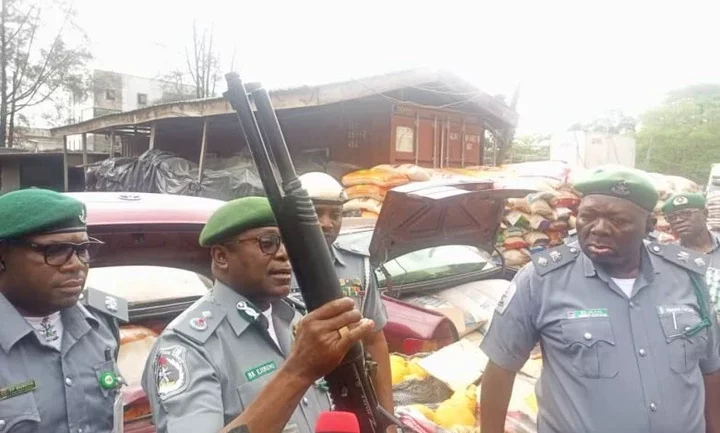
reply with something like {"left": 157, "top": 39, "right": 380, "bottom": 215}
{"left": 0, "top": 0, "right": 92, "bottom": 146}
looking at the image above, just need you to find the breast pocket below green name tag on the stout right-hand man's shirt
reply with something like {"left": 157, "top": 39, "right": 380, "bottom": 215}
{"left": 562, "top": 317, "right": 618, "bottom": 379}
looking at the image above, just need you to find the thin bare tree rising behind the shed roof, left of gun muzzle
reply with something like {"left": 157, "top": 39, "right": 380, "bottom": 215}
{"left": 163, "top": 21, "right": 222, "bottom": 102}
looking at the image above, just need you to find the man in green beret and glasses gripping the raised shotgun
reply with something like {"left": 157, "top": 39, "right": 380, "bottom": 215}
{"left": 142, "top": 197, "right": 374, "bottom": 433}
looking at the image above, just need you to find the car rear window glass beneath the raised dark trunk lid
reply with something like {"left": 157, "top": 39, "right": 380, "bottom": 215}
{"left": 339, "top": 230, "right": 497, "bottom": 288}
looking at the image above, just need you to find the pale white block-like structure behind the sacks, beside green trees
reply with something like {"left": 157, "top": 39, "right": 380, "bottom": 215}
{"left": 550, "top": 131, "right": 635, "bottom": 168}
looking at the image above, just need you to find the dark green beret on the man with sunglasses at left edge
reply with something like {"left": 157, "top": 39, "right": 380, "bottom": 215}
{"left": 0, "top": 188, "right": 87, "bottom": 239}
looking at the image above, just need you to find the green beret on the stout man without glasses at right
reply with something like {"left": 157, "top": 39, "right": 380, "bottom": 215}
{"left": 573, "top": 166, "right": 659, "bottom": 212}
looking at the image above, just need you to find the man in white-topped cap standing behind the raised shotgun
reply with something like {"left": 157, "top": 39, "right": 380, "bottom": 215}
{"left": 293, "top": 172, "right": 396, "bottom": 432}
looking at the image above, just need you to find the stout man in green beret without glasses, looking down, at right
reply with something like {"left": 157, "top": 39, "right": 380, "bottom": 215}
{"left": 480, "top": 167, "right": 720, "bottom": 433}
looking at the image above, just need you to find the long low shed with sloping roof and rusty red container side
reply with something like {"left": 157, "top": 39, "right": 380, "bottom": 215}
{"left": 52, "top": 69, "right": 518, "bottom": 192}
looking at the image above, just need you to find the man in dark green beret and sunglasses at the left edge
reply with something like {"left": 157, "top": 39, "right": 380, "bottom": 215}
{"left": 0, "top": 189, "right": 127, "bottom": 433}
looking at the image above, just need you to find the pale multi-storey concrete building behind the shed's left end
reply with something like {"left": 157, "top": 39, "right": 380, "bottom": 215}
{"left": 61, "top": 69, "right": 195, "bottom": 157}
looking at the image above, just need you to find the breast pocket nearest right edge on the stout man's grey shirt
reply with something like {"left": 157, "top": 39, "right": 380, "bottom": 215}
{"left": 658, "top": 311, "right": 707, "bottom": 374}
